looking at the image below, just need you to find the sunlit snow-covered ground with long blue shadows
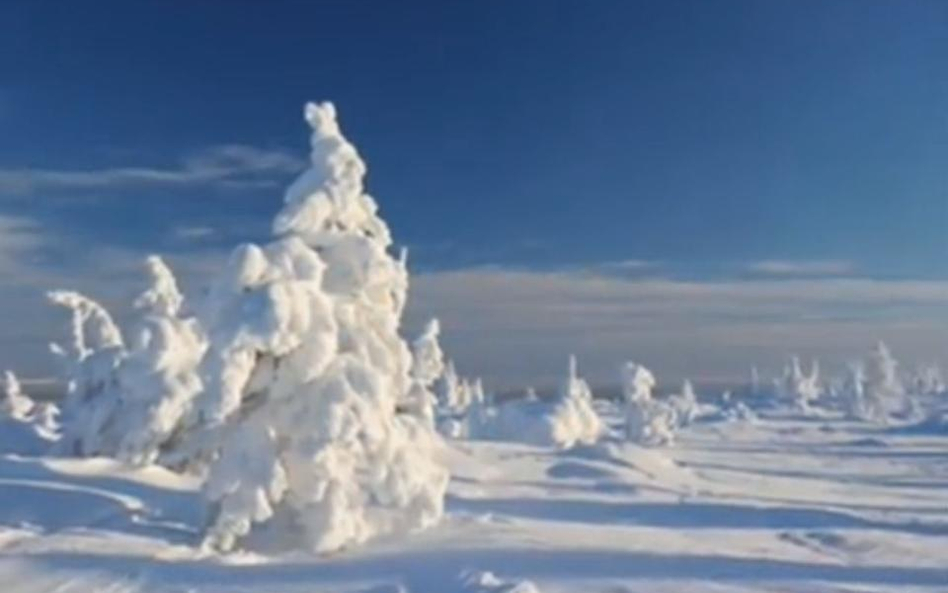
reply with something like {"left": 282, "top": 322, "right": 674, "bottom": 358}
{"left": 0, "top": 404, "right": 948, "bottom": 593}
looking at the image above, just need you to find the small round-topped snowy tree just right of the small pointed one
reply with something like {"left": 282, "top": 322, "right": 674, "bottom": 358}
{"left": 622, "top": 362, "right": 675, "bottom": 445}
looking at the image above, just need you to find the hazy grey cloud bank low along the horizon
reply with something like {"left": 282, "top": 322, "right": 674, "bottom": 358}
{"left": 0, "top": 216, "right": 948, "bottom": 388}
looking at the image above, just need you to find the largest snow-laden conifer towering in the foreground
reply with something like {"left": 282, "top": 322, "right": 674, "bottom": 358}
{"left": 194, "top": 103, "right": 448, "bottom": 552}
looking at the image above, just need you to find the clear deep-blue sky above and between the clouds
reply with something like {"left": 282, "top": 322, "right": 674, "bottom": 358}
{"left": 0, "top": 0, "right": 948, "bottom": 275}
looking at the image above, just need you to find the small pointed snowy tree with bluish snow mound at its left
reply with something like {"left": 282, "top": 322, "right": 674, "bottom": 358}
{"left": 486, "top": 357, "right": 605, "bottom": 449}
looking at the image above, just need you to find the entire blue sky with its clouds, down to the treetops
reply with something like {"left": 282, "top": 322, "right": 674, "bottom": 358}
{"left": 0, "top": 0, "right": 948, "bottom": 383}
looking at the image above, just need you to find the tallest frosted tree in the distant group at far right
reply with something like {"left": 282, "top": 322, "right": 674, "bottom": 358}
{"left": 842, "top": 341, "right": 911, "bottom": 423}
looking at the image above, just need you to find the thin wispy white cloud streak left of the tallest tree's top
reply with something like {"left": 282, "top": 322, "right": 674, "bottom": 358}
{"left": 0, "top": 144, "right": 305, "bottom": 195}
